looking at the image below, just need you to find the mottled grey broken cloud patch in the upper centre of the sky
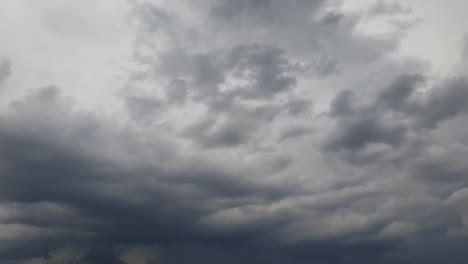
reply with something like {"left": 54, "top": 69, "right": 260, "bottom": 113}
{"left": 133, "top": 42, "right": 311, "bottom": 148}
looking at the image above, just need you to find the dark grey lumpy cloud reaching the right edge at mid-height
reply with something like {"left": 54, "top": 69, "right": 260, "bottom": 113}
{"left": 324, "top": 74, "right": 468, "bottom": 155}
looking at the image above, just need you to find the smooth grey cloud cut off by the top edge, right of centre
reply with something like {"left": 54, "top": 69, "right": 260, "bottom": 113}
{"left": 208, "top": 0, "right": 395, "bottom": 64}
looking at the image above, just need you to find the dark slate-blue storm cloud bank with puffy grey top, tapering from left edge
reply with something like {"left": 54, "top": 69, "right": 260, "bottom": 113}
{"left": 0, "top": 86, "right": 310, "bottom": 263}
